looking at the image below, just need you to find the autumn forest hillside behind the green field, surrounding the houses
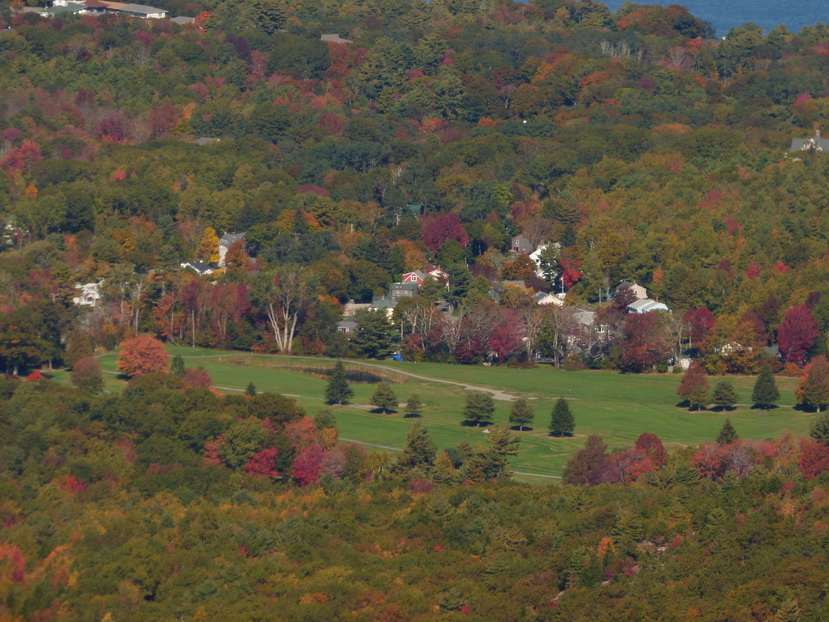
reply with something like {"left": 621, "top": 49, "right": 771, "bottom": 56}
{"left": 0, "top": 0, "right": 829, "bottom": 373}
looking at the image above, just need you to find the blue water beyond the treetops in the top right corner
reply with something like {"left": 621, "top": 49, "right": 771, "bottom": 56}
{"left": 604, "top": 0, "right": 829, "bottom": 37}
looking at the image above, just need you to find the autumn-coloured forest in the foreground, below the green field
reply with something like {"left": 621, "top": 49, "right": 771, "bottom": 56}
{"left": 0, "top": 373, "right": 829, "bottom": 620}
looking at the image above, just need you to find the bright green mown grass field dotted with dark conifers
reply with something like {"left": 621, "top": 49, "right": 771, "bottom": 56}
{"left": 56, "top": 346, "right": 815, "bottom": 479}
